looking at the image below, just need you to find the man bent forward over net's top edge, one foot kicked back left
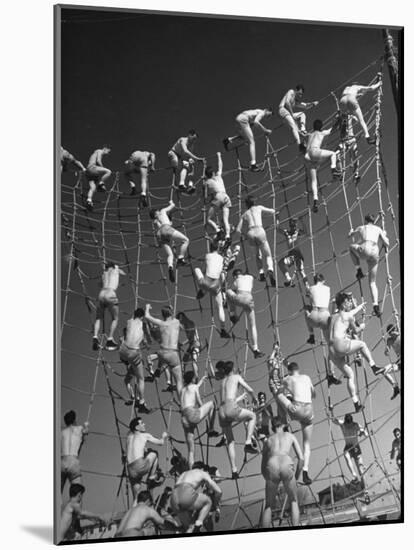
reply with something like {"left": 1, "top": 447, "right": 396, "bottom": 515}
{"left": 223, "top": 107, "right": 273, "bottom": 172}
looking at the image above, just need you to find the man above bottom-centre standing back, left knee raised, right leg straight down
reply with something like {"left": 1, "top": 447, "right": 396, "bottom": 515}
{"left": 277, "top": 363, "right": 316, "bottom": 485}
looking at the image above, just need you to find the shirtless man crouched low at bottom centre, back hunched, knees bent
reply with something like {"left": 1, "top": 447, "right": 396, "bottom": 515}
{"left": 171, "top": 462, "right": 222, "bottom": 533}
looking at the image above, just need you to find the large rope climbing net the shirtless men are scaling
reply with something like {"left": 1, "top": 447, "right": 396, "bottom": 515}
{"left": 61, "top": 60, "right": 399, "bottom": 540}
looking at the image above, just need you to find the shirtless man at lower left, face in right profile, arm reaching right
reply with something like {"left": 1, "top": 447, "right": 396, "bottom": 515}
{"left": 127, "top": 417, "right": 168, "bottom": 499}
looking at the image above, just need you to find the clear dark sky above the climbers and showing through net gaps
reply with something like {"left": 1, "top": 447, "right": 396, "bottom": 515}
{"left": 62, "top": 4, "right": 400, "bottom": 532}
